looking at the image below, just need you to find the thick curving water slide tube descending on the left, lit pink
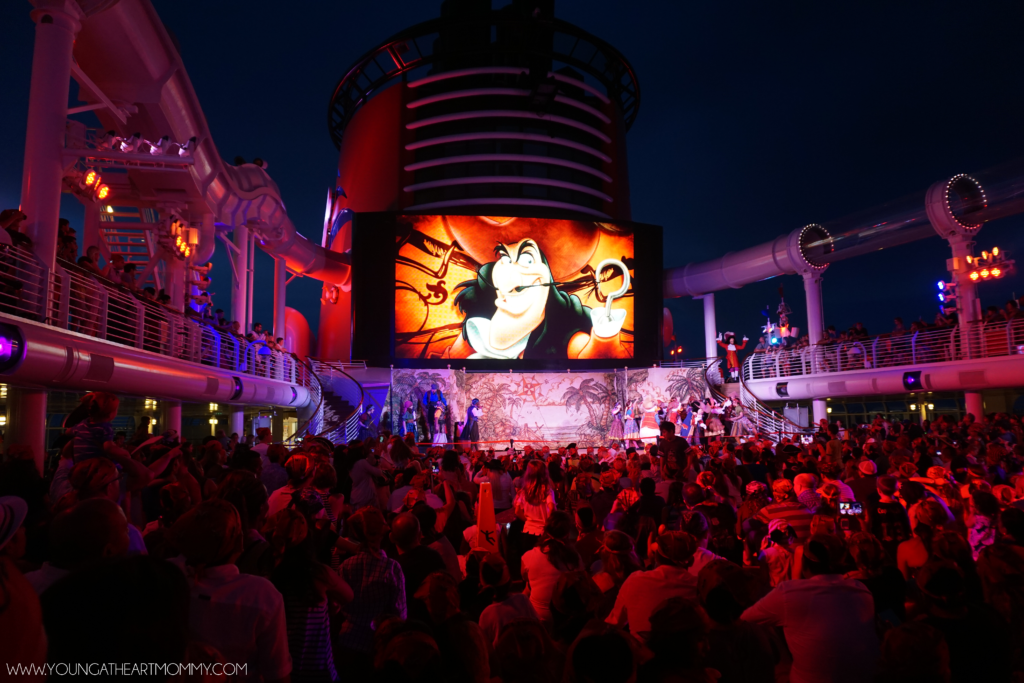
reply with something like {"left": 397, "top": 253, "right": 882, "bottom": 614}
{"left": 74, "top": 0, "right": 350, "bottom": 286}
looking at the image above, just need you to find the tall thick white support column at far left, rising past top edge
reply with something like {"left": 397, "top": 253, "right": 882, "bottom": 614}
{"left": 20, "top": 0, "right": 84, "bottom": 270}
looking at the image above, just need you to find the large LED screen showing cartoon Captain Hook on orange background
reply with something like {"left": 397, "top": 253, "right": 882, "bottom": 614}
{"left": 353, "top": 214, "right": 660, "bottom": 365}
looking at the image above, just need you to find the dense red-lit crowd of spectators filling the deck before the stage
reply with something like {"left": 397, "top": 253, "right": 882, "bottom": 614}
{"left": 0, "top": 392, "right": 1024, "bottom": 683}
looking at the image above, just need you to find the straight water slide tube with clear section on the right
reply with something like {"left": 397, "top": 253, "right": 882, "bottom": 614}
{"left": 664, "top": 160, "right": 1024, "bottom": 298}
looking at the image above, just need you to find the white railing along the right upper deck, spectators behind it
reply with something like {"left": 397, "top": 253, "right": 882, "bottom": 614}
{"left": 742, "top": 317, "right": 1024, "bottom": 381}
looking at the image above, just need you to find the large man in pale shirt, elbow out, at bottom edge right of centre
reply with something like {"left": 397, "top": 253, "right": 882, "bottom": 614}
{"left": 741, "top": 535, "right": 879, "bottom": 683}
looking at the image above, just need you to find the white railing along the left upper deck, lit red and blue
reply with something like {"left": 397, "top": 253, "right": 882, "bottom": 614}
{"left": 0, "top": 250, "right": 319, "bottom": 397}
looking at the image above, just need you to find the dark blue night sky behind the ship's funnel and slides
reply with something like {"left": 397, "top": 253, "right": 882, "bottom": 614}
{"left": 0, "top": 0, "right": 1024, "bottom": 356}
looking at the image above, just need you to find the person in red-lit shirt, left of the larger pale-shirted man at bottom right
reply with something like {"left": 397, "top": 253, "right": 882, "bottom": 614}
{"left": 605, "top": 531, "right": 697, "bottom": 639}
